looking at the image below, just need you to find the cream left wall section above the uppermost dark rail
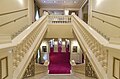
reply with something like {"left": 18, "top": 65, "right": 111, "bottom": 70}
{"left": 0, "top": 0, "right": 28, "bottom": 13}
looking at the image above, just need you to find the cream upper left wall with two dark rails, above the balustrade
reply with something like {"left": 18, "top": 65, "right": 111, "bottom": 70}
{"left": 0, "top": 0, "right": 34, "bottom": 36}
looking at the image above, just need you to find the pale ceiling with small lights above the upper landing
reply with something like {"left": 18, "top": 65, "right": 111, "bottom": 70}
{"left": 36, "top": 0, "right": 85, "bottom": 8}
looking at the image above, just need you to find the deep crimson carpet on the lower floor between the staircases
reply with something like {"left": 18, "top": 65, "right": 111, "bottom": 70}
{"left": 48, "top": 48, "right": 71, "bottom": 74}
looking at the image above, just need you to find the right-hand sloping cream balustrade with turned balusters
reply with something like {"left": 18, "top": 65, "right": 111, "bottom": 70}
{"left": 72, "top": 14, "right": 108, "bottom": 78}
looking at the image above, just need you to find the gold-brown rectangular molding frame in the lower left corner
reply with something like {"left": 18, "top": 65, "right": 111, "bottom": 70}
{"left": 0, "top": 57, "right": 8, "bottom": 79}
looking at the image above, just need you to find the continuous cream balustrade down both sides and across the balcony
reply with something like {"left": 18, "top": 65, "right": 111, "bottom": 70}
{"left": 0, "top": 14, "right": 120, "bottom": 79}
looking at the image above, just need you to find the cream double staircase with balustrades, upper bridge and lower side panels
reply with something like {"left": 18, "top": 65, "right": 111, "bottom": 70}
{"left": 0, "top": 13, "right": 120, "bottom": 79}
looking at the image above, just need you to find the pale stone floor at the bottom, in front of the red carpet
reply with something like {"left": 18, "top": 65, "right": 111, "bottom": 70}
{"left": 26, "top": 73, "right": 95, "bottom": 79}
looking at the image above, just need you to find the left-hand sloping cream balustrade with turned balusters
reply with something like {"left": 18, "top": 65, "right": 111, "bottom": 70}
{"left": 13, "top": 15, "right": 47, "bottom": 78}
